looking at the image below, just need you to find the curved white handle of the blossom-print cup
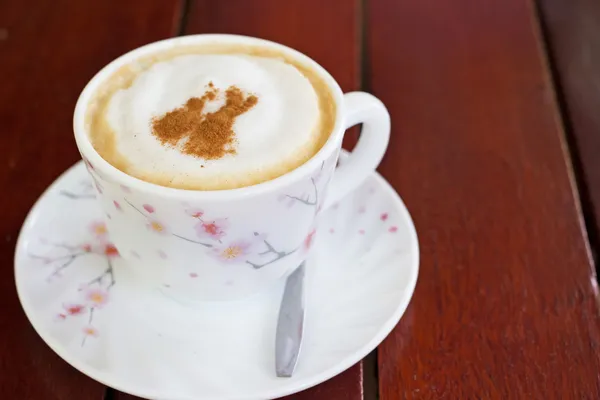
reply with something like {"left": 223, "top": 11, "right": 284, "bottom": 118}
{"left": 324, "top": 92, "right": 390, "bottom": 208}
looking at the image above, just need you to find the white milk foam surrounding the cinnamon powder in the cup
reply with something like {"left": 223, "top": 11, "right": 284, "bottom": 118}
{"left": 100, "top": 54, "right": 329, "bottom": 190}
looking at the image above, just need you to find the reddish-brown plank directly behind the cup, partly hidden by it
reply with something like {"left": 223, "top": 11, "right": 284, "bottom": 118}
{"left": 116, "top": 0, "right": 363, "bottom": 400}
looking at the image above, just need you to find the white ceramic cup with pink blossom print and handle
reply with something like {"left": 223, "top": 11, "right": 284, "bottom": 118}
{"left": 73, "top": 35, "right": 390, "bottom": 302}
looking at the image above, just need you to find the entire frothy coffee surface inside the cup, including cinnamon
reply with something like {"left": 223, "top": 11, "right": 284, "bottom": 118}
{"left": 86, "top": 44, "right": 336, "bottom": 190}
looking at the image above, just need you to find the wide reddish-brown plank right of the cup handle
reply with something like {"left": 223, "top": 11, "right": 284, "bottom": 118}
{"left": 367, "top": 0, "right": 600, "bottom": 400}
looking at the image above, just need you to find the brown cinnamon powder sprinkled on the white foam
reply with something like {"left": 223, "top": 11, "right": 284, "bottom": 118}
{"left": 152, "top": 82, "right": 258, "bottom": 160}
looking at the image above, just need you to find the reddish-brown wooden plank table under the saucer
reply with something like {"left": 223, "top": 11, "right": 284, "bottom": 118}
{"left": 0, "top": 0, "right": 600, "bottom": 400}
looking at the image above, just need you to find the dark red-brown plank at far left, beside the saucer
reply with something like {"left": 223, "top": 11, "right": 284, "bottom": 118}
{"left": 0, "top": 0, "right": 180, "bottom": 400}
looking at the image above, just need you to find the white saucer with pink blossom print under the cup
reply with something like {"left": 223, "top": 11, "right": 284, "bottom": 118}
{"left": 15, "top": 162, "right": 419, "bottom": 400}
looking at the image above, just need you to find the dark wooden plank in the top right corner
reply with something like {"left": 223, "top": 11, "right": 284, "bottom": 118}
{"left": 537, "top": 0, "right": 600, "bottom": 260}
